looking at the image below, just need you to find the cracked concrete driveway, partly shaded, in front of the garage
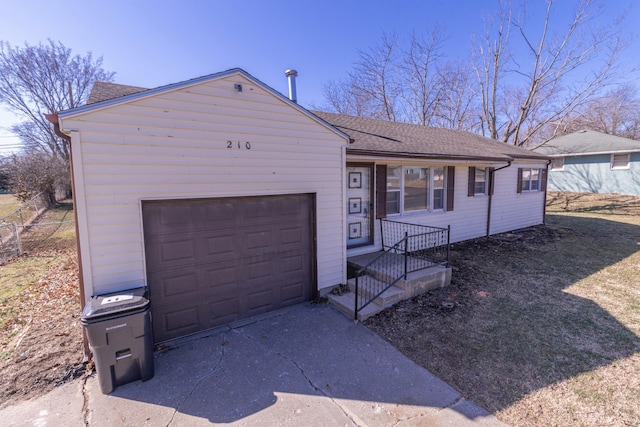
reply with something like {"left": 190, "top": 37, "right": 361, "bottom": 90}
{"left": 0, "top": 304, "right": 503, "bottom": 426}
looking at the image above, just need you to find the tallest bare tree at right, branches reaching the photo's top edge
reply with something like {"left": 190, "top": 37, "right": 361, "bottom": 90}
{"left": 475, "top": 0, "right": 625, "bottom": 146}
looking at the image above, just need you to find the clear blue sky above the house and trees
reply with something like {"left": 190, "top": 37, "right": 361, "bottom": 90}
{"left": 0, "top": 0, "right": 640, "bottom": 149}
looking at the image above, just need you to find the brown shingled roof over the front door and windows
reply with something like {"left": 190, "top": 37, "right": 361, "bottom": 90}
{"left": 313, "top": 111, "right": 547, "bottom": 161}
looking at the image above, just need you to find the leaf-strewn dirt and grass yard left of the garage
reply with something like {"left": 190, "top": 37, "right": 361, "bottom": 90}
{"left": 0, "top": 207, "right": 85, "bottom": 407}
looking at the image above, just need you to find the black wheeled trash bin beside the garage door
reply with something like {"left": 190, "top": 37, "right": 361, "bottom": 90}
{"left": 81, "top": 287, "right": 153, "bottom": 394}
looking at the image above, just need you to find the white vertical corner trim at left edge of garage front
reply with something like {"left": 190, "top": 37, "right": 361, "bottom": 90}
{"left": 71, "top": 131, "right": 93, "bottom": 305}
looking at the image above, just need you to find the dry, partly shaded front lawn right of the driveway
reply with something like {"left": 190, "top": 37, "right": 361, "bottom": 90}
{"left": 367, "top": 193, "right": 640, "bottom": 426}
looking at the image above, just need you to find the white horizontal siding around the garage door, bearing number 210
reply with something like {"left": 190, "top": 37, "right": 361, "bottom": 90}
{"left": 63, "top": 75, "right": 346, "bottom": 296}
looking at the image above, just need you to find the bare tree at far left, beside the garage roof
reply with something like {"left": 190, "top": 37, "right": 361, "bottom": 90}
{"left": 0, "top": 40, "right": 115, "bottom": 162}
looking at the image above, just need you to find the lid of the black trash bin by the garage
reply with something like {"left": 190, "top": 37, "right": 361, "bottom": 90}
{"left": 80, "top": 287, "right": 149, "bottom": 323}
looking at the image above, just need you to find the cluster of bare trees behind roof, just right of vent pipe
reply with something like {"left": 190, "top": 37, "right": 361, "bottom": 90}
{"left": 324, "top": 28, "right": 478, "bottom": 130}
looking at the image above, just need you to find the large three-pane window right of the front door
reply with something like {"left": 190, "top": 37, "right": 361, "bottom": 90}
{"left": 385, "top": 166, "right": 444, "bottom": 215}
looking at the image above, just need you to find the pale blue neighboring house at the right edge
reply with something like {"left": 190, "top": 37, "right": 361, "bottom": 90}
{"left": 533, "top": 130, "right": 640, "bottom": 195}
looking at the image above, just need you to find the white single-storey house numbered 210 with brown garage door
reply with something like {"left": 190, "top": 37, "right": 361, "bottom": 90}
{"left": 52, "top": 69, "right": 547, "bottom": 342}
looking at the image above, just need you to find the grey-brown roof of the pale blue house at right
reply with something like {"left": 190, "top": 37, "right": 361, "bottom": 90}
{"left": 533, "top": 130, "right": 640, "bottom": 157}
